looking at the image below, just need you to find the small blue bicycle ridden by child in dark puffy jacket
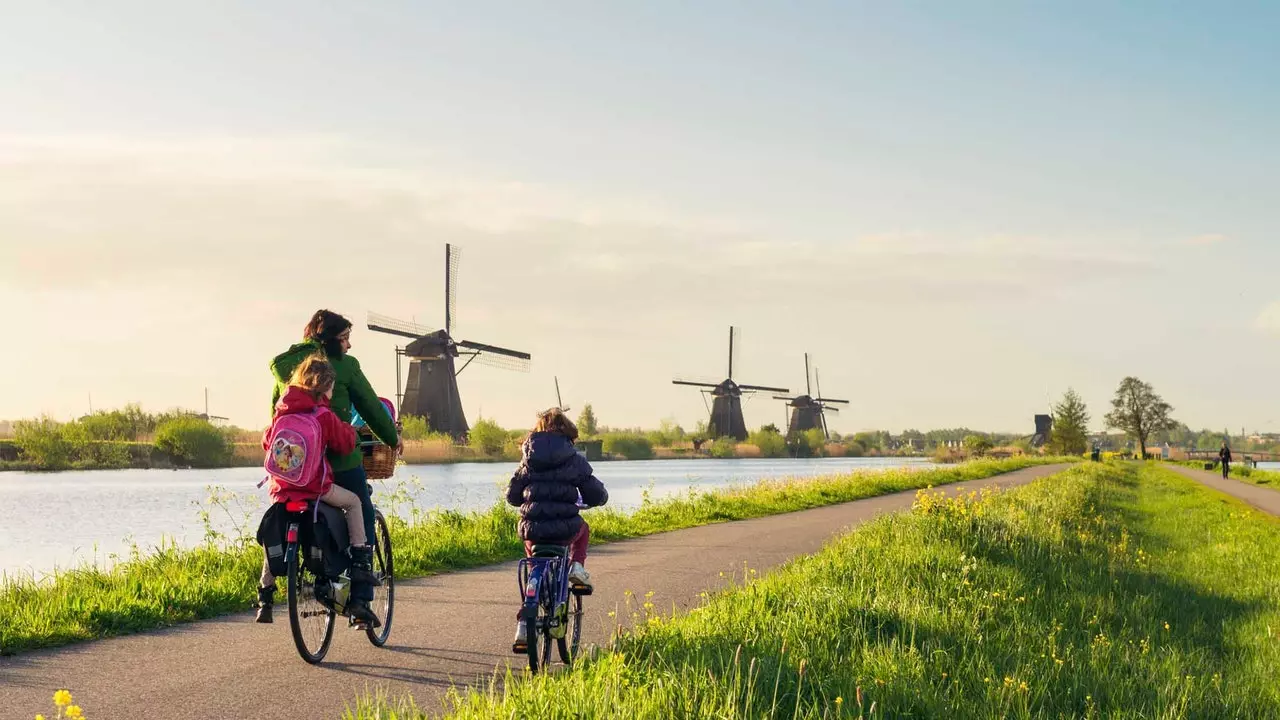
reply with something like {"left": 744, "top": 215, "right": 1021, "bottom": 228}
{"left": 516, "top": 544, "right": 591, "bottom": 674}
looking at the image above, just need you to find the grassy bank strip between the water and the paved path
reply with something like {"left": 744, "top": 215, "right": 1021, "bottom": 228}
{"left": 0, "top": 459, "right": 1070, "bottom": 655}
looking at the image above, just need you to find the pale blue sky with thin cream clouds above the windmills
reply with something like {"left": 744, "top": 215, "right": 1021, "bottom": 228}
{"left": 0, "top": 0, "right": 1280, "bottom": 434}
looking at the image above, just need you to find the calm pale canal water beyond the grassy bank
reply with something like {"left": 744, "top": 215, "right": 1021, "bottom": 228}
{"left": 0, "top": 457, "right": 929, "bottom": 577}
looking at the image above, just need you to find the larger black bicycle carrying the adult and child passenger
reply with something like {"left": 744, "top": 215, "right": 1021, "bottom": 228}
{"left": 284, "top": 500, "right": 396, "bottom": 665}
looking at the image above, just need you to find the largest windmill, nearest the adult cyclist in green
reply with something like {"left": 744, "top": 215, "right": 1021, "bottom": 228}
{"left": 369, "top": 245, "right": 531, "bottom": 439}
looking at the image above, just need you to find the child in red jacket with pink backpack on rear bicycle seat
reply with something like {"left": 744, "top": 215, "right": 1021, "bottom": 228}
{"left": 257, "top": 355, "right": 381, "bottom": 628}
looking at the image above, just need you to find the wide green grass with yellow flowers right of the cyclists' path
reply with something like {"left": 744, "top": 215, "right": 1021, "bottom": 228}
{"left": 347, "top": 464, "right": 1280, "bottom": 720}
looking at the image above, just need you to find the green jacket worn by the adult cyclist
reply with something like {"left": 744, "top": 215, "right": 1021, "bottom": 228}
{"left": 264, "top": 341, "right": 399, "bottom": 473}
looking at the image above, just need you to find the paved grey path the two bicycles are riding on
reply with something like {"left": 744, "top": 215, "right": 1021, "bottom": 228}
{"left": 0, "top": 465, "right": 1065, "bottom": 720}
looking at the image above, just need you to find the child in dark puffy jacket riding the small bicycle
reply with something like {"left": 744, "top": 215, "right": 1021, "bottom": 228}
{"left": 507, "top": 407, "right": 609, "bottom": 652}
